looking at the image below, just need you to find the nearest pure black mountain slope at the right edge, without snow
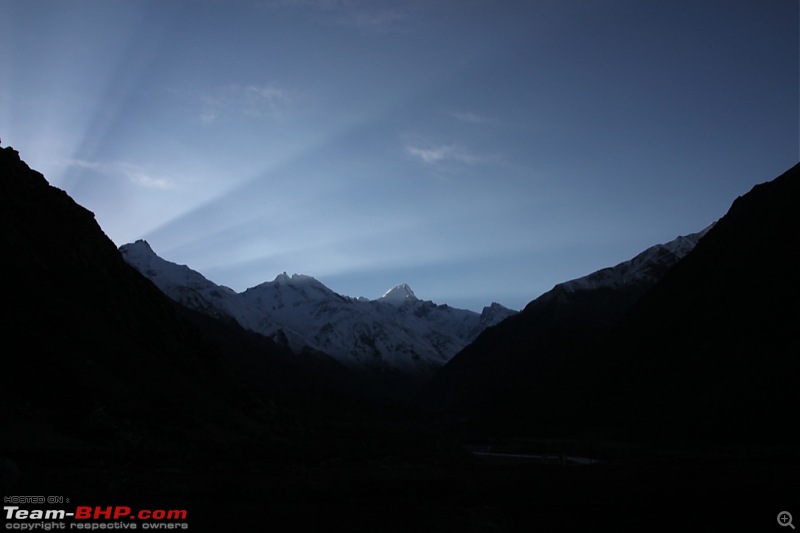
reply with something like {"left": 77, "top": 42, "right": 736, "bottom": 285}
{"left": 595, "top": 165, "right": 800, "bottom": 445}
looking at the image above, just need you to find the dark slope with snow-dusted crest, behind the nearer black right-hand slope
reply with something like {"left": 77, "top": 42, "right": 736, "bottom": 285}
{"left": 426, "top": 229, "right": 708, "bottom": 409}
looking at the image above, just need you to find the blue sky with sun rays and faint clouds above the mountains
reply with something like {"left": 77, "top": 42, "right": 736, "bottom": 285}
{"left": 0, "top": 0, "right": 800, "bottom": 311}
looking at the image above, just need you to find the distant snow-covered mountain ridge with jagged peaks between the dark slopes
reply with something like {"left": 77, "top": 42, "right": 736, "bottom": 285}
{"left": 120, "top": 240, "right": 515, "bottom": 375}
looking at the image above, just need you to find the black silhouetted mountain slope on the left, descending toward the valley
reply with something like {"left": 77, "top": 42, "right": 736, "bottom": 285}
{"left": 0, "top": 148, "right": 284, "bottom": 449}
